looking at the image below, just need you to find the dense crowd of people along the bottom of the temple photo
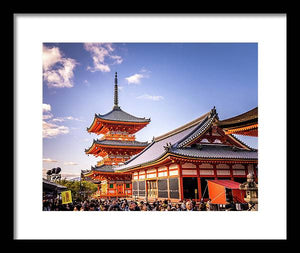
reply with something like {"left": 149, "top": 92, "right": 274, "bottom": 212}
{"left": 43, "top": 198, "right": 247, "bottom": 211}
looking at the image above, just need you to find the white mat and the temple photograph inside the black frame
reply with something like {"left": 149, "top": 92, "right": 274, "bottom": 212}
{"left": 14, "top": 14, "right": 286, "bottom": 240}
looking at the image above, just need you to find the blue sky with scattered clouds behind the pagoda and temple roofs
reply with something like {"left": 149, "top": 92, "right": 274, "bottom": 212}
{"left": 43, "top": 43, "right": 258, "bottom": 177}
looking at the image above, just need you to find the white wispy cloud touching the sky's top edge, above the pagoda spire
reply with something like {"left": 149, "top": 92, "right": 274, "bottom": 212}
{"left": 84, "top": 43, "right": 123, "bottom": 72}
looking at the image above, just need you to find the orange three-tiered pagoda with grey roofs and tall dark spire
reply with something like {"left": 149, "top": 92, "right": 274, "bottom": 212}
{"left": 83, "top": 72, "right": 150, "bottom": 197}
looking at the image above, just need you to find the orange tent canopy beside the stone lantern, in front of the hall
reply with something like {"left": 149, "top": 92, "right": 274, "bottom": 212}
{"left": 207, "top": 180, "right": 246, "bottom": 205}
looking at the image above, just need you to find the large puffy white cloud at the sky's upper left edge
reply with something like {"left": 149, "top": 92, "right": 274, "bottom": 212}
{"left": 43, "top": 46, "right": 77, "bottom": 88}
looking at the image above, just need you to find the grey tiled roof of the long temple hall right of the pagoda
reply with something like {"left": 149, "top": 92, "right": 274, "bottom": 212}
{"left": 115, "top": 108, "right": 257, "bottom": 170}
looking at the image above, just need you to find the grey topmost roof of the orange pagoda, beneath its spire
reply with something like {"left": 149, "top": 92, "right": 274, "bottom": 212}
{"left": 95, "top": 107, "right": 150, "bottom": 123}
